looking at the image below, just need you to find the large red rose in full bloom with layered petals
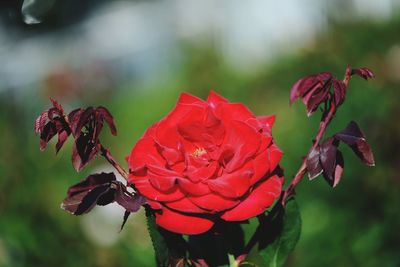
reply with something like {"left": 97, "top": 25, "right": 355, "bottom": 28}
{"left": 129, "top": 92, "right": 283, "bottom": 234}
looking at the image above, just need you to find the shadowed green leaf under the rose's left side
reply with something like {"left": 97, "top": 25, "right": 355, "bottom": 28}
{"left": 146, "top": 206, "right": 187, "bottom": 267}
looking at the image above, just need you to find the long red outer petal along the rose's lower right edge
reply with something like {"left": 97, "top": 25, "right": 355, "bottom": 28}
{"left": 221, "top": 175, "right": 282, "bottom": 221}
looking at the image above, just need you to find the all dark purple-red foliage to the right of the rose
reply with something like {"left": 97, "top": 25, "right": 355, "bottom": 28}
{"left": 298, "top": 66, "right": 375, "bottom": 187}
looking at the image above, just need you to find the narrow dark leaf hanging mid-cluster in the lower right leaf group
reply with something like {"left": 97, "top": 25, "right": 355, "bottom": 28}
{"left": 320, "top": 137, "right": 337, "bottom": 185}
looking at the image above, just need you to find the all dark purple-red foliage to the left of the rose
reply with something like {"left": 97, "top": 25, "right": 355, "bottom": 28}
{"left": 35, "top": 99, "right": 146, "bottom": 229}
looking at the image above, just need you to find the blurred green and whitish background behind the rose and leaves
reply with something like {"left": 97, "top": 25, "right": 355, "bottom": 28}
{"left": 0, "top": 0, "right": 400, "bottom": 267}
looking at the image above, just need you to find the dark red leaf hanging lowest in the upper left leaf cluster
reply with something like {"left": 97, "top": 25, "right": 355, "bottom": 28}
{"left": 72, "top": 134, "right": 100, "bottom": 171}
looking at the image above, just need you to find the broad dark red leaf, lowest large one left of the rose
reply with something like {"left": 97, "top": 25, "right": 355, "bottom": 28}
{"left": 61, "top": 173, "right": 115, "bottom": 215}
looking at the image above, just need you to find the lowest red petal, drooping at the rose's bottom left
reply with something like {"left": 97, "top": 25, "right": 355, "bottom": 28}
{"left": 156, "top": 208, "right": 214, "bottom": 235}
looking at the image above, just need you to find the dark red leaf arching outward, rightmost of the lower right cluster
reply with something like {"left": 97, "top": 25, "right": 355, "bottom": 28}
{"left": 334, "top": 121, "right": 375, "bottom": 166}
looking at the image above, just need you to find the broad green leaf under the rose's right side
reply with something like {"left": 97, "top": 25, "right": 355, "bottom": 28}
{"left": 245, "top": 198, "right": 301, "bottom": 267}
